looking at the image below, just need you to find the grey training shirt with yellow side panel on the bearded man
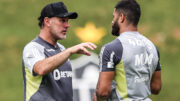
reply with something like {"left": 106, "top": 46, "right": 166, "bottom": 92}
{"left": 101, "top": 32, "right": 159, "bottom": 101}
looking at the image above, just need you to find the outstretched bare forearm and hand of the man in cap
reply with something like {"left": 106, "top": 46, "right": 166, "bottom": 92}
{"left": 33, "top": 42, "right": 96, "bottom": 75}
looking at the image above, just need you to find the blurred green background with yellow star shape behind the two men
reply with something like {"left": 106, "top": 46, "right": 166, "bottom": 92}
{"left": 0, "top": 0, "right": 180, "bottom": 101}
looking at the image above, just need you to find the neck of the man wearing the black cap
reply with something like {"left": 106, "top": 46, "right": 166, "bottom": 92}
{"left": 39, "top": 29, "right": 57, "bottom": 47}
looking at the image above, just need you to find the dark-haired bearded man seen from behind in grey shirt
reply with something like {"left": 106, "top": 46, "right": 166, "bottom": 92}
{"left": 94, "top": 0, "right": 161, "bottom": 101}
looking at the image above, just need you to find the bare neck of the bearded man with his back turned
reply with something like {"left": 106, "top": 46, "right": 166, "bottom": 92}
{"left": 119, "top": 24, "right": 137, "bottom": 34}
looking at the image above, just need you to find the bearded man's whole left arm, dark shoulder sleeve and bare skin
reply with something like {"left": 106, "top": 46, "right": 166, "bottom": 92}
{"left": 93, "top": 39, "right": 123, "bottom": 101}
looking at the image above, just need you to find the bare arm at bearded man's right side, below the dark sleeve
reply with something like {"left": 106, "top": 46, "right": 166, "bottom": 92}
{"left": 150, "top": 71, "right": 162, "bottom": 95}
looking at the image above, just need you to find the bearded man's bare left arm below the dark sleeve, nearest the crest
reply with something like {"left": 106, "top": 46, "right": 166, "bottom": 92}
{"left": 94, "top": 71, "right": 114, "bottom": 101}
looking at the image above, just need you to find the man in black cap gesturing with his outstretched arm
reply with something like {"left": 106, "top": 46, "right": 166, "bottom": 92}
{"left": 22, "top": 2, "right": 96, "bottom": 101}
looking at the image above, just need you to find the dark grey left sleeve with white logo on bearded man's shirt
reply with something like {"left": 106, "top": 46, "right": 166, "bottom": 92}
{"left": 99, "top": 39, "right": 123, "bottom": 71}
